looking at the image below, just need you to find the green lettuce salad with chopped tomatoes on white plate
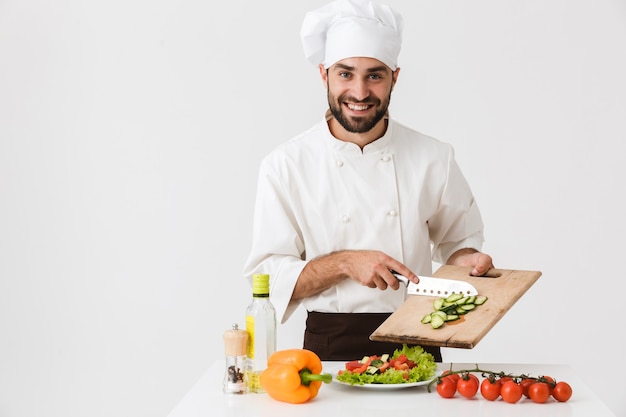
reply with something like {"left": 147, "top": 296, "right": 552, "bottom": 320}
{"left": 337, "top": 344, "right": 437, "bottom": 385}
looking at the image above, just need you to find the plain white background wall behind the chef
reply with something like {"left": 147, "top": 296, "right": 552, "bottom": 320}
{"left": 0, "top": 0, "right": 626, "bottom": 417}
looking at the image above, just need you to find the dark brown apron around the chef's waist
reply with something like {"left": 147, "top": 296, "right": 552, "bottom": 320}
{"left": 303, "top": 311, "right": 442, "bottom": 362}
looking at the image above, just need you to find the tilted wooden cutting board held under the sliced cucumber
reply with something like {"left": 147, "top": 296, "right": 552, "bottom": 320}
{"left": 370, "top": 265, "right": 541, "bottom": 349}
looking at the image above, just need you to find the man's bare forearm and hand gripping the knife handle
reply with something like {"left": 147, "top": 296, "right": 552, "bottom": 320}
{"left": 292, "top": 250, "right": 419, "bottom": 300}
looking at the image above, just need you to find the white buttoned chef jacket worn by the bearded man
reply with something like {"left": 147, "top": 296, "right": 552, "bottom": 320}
{"left": 244, "top": 113, "right": 483, "bottom": 323}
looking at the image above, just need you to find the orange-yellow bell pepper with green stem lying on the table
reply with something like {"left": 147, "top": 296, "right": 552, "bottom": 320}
{"left": 260, "top": 349, "right": 333, "bottom": 404}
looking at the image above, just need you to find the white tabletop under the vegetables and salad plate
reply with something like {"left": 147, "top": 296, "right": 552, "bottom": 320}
{"left": 168, "top": 361, "right": 616, "bottom": 417}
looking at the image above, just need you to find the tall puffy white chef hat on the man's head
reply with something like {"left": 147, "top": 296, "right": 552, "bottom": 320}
{"left": 300, "top": 0, "right": 404, "bottom": 70}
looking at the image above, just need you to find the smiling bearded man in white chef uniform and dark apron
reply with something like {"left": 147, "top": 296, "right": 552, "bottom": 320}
{"left": 244, "top": 0, "right": 493, "bottom": 361}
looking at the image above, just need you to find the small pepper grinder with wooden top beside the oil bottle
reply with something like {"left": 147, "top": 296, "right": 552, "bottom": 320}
{"left": 224, "top": 323, "right": 248, "bottom": 394}
